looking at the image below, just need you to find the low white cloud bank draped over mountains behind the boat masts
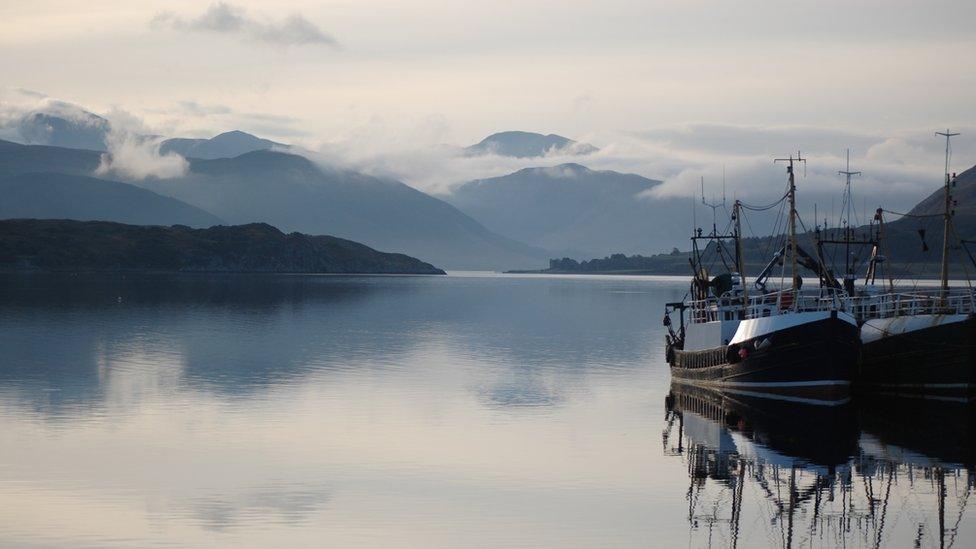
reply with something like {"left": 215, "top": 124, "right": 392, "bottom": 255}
{"left": 318, "top": 120, "right": 976, "bottom": 229}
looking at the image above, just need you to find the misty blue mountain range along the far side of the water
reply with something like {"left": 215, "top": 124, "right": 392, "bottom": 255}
{"left": 0, "top": 100, "right": 976, "bottom": 270}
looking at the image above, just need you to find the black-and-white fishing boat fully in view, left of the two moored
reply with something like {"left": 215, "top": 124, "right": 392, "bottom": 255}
{"left": 664, "top": 155, "right": 860, "bottom": 403}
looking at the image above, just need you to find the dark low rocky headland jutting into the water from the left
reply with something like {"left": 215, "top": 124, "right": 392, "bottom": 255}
{"left": 0, "top": 219, "right": 444, "bottom": 274}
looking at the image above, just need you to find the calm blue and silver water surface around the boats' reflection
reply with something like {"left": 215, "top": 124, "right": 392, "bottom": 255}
{"left": 0, "top": 275, "right": 976, "bottom": 547}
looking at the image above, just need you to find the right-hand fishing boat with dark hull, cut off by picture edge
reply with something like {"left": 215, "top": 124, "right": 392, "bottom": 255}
{"left": 842, "top": 130, "right": 976, "bottom": 398}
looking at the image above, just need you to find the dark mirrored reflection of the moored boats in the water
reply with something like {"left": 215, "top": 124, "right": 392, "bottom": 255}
{"left": 663, "top": 384, "right": 976, "bottom": 547}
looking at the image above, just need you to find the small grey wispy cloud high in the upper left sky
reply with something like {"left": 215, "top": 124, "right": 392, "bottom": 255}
{"left": 149, "top": 2, "right": 339, "bottom": 48}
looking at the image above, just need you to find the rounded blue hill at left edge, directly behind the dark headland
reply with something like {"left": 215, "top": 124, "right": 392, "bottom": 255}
{"left": 0, "top": 173, "right": 222, "bottom": 227}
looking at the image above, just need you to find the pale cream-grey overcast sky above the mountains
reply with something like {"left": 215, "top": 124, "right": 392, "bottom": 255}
{"left": 0, "top": 0, "right": 976, "bottom": 212}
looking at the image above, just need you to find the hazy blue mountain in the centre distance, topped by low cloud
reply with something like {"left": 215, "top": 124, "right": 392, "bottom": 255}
{"left": 445, "top": 164, "right": 691, "bottom": 257}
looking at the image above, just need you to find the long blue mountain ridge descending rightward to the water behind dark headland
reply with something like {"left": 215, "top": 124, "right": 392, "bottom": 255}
{"left": 0, "top": 141, "right": 548, "bottom": 270}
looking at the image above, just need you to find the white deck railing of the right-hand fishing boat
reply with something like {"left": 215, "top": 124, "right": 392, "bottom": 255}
{"left": 848, "top": 288, "right": 976, "bottom": 321}
